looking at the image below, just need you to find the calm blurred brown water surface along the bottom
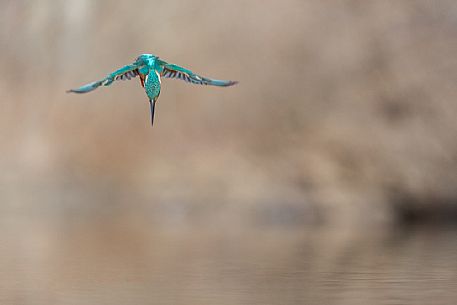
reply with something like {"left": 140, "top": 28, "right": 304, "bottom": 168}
{"left": 0, "top": 213, "right": 457, "bottom": 305}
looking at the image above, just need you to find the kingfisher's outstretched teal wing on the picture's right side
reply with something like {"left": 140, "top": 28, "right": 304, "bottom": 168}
{"left": 161, "top": 61, "right": 238, "bottom": 87}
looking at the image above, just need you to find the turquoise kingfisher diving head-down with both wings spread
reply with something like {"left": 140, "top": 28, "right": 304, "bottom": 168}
{"left": 67, "top": 54, "right": 238, "bottom": 125}
